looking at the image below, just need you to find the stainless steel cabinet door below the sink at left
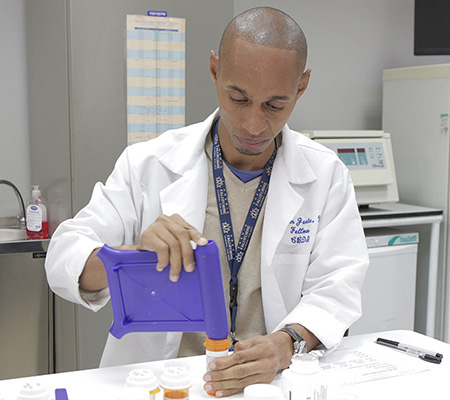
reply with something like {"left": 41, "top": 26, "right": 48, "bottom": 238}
{"left": 0, "top": 253, "right": 53, "bottom": 379}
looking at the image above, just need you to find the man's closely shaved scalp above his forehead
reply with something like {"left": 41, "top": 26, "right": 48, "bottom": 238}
{"left": 219, "top": 7, "right": 307, "bottom": 73}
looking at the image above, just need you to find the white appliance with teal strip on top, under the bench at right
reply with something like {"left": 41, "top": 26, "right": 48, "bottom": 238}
{"left": 349, "top": 228, "right": 419, "bottom": 335}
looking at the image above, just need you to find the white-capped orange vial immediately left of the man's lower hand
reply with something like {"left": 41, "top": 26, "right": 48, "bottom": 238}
{"left": 159, "top": 361, "right": 192, "bottom": 400}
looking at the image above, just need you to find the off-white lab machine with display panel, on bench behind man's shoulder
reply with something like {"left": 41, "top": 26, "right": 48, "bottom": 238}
{"left": 302, "top": 130, "right": 399, "bottom": 205}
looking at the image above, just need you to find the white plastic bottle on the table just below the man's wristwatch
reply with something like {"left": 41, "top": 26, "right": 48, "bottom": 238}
{"left": 281, "top": 354, "right": 328, "bottom": 400}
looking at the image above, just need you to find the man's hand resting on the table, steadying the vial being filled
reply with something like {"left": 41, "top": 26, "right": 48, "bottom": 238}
{"left": 203, "top": 332, "right": 292, "bottom": 397}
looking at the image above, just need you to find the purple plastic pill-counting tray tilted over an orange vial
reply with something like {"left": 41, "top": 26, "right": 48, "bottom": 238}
{"left": 97, "top": 241, "right": 228, "bottom": 340}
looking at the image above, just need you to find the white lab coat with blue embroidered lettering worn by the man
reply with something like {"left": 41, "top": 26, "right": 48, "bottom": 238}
{"left": 46, "top": 110, "right": 368, "bottom": 366}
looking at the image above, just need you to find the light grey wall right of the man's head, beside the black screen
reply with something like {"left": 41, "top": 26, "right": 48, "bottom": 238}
{"left": 234, "top": 0, "right": 450, "bottom": 131}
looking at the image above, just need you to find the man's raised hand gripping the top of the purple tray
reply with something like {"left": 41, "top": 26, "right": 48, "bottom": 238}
{"left": 138, "top": 214, "right": 208, "bottom": 282}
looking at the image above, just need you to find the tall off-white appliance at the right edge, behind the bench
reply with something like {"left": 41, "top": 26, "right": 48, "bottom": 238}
{"left": 383, "top": 64, "right": 450, "bottom": 342}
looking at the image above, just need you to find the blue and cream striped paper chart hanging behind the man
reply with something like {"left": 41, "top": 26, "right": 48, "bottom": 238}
{"left": 127, "top": 15, "right": 186, "bottom": 145}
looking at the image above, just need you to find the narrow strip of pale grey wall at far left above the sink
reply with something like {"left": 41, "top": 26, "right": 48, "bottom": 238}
{"left": 0, "top": 0, "right": 31, "bottom": 217}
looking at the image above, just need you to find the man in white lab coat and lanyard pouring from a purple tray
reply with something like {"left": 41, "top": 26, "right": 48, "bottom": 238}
{"left": 46, "top": 7, "right": 368, "bottom": 397}
